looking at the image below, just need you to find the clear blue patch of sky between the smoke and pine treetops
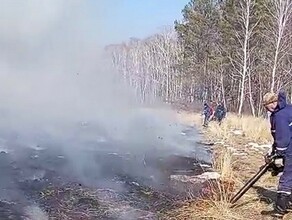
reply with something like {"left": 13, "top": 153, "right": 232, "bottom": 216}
{"left": 91, "top": 0, "right": 189, "bottom": 44}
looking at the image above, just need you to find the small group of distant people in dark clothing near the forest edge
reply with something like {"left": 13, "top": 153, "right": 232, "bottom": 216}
{"left": 203, "top": 102, "right": 226, "bottom": 127}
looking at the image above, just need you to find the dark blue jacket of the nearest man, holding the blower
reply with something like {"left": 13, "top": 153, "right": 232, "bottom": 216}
{"left": 270, "top": 91, "right": 292, "bottom": 156}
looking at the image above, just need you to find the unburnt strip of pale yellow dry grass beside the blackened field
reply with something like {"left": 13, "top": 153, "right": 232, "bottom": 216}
{"left": 170, "top": 111, "right": 292, "bottom": 220}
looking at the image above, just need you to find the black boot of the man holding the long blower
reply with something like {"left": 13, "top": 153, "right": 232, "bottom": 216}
{"left": 262, "top": 193, "right": 291, "bottom": 219}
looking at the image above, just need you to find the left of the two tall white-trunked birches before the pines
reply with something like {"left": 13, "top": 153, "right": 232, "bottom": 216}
{"left": 223, "top": 0, "right": 259, "bottom": 115}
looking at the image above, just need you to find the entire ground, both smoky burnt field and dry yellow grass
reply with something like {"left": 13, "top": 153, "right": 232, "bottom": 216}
{"left": 0, "top": 107, "right": 291, "bottom": 220}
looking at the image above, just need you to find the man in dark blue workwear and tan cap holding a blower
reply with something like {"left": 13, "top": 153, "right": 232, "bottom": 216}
{"left": 263, "top": 91, "right": 292, "bottom": 218}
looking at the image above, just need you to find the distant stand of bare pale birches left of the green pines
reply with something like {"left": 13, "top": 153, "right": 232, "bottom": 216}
{"left": 106, "top": 28, "right": 183, "bottom": 105}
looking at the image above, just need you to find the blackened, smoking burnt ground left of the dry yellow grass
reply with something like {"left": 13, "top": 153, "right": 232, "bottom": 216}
{"left": 0, "top": 124, "right": 211, "bottom": 220}
